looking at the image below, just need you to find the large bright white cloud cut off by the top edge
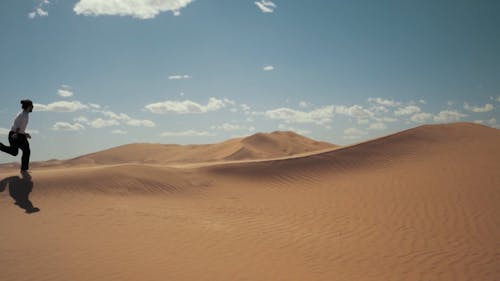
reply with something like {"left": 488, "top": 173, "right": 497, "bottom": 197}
{"left": 73, "top": 0, "right": 194, "bottom": 19}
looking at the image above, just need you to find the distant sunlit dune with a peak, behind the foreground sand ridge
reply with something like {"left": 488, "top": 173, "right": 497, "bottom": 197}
{"left": 64, "top": 131, "right": 337, "bottom": 165}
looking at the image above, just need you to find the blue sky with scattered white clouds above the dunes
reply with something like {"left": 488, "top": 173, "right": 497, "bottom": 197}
{"left": 0, "top": 0, "right": 500, "bottom": 163}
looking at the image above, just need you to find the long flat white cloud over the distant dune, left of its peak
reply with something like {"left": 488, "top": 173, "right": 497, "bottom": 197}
{"left": 145, "top": 97, "right": 232, "bottom": 114}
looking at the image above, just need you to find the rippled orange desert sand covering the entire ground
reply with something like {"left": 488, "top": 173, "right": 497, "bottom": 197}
{"left": 0, "top": 123, "right": 500, "bottom": 281}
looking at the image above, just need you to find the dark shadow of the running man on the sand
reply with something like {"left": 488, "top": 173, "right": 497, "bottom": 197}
{"left": 0, "top": 172, "right": 40, "bottom": 214}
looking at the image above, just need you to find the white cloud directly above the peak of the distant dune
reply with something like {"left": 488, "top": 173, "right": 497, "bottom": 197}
{"left": 264, "top": 105, "right": 334, "bottom": 125}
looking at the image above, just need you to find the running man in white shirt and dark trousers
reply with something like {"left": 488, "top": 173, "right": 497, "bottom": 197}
{"left": 0, "top": 100, "right": 33, "bottom": 172}
